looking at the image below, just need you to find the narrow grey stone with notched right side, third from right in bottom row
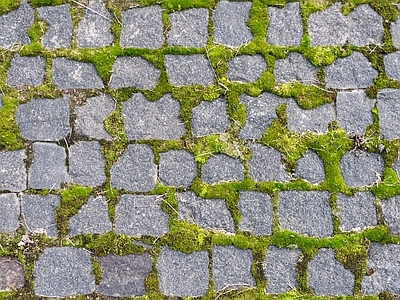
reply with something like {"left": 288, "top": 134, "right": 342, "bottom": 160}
{"left": 264, "top": 246, "right": 301, "bottom": 294}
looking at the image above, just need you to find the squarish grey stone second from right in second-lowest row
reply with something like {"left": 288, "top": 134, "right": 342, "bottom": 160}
{"left": 336, "top": 192, "right": 377, "bottom": 231}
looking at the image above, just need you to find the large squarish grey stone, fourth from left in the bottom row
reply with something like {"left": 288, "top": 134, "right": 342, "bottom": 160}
{"left": 156, "top": 247, "right": 210, "bottom": 297}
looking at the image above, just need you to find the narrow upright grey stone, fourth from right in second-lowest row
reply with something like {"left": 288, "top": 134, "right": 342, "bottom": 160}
{"left": 238, "top": 191, "right": 272, "bottom": 235}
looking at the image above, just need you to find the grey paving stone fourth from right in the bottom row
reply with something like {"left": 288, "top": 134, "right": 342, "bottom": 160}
{"left": 212, "top": 246, "right": 256, "bottom": 291}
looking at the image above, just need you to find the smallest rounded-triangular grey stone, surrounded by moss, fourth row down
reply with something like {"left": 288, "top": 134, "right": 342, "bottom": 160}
{"left": 294, "top": 150, "right": 325, "bottom": 184}
